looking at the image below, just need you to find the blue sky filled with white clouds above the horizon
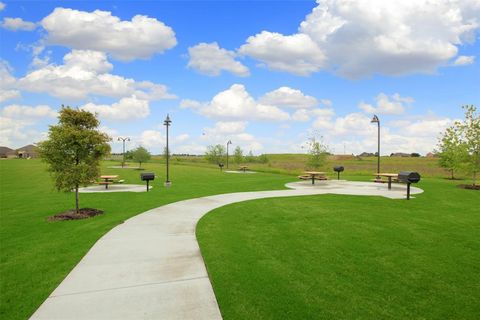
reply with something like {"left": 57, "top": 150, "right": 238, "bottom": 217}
{"left": 0, "top": 0, "right": 480, "bottom": 154}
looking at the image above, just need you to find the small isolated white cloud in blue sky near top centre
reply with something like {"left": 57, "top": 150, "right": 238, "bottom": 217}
{"left": 188, "top": 42, "right": 250, "bottom": 77}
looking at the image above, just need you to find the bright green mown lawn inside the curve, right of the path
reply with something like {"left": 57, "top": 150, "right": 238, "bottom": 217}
{"left": 197, "top": 179, "right": 480, "bottom": 320}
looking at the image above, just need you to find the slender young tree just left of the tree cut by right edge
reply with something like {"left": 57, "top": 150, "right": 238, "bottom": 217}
{"left": 438, "top": 124, "right": 466, "bottom": 180}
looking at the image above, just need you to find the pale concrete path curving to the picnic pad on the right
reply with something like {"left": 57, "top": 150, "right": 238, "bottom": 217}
{"left": 31, "top": 181, "right": 422, "bottom": 320}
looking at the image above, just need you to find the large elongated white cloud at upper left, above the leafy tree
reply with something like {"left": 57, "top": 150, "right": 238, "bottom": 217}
{"left": 41, "top": 8, "right": 177, "bottom": 61}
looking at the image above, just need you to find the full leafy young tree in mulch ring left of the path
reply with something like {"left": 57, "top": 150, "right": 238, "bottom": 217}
{"left": 39, "top": 106, "right": 110, "bottom": 213}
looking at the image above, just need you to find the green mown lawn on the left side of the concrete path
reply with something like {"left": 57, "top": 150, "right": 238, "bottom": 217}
{"left": 0, "top": 159, "right": 292, "bottom": 319}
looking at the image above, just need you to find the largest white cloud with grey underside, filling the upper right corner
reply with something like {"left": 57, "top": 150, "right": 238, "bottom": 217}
{"left": 239, "top": 0, "right": 480, "bottom": 78}
